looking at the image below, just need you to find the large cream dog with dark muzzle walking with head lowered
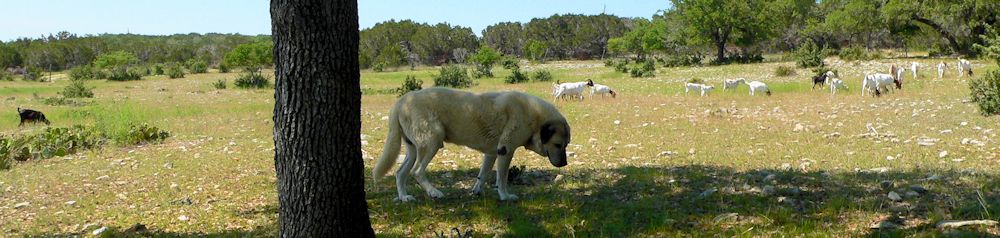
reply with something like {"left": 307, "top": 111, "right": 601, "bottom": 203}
{"left": 372, "top": 88, "right": 570, "bottom": 202}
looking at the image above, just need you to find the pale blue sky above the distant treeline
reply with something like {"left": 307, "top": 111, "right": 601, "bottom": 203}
{"left": 0, "top": 0, "right": 669, "bottom": 41}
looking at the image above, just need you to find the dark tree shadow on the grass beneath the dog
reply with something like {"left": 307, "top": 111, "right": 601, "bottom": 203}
{"left": 368, "top": 166, "right": 1000, "bottom": 237}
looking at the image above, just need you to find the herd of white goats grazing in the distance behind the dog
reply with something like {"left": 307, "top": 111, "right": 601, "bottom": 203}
{"left": 552, "top": 58, "right": 972, "bottom": 100}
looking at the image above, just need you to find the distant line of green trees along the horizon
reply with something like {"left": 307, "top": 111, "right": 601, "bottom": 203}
{"left": 0, "top": 0, "right": 1000, "bottom": 73}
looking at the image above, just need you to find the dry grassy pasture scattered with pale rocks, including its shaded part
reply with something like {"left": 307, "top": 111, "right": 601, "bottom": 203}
{"left": 0, "top": 59, "right": 1000, "bottom": 237}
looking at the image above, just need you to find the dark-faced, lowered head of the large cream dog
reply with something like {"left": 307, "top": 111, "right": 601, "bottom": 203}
{"left": 526, "top": 120, "right": 570, "bottom": 167}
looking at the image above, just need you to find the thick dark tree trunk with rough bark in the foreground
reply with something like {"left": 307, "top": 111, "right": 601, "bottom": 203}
{"left": 271, "top": 0, "right": 374, "bottom": 237}
